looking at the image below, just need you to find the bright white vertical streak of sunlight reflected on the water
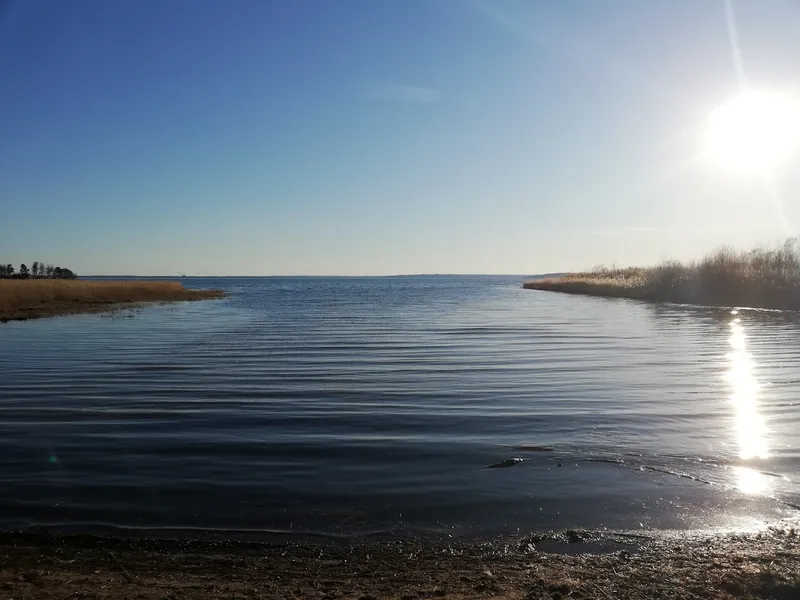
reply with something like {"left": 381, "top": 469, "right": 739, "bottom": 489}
{"left": 726, "top": 311, "right": 769, "bottom": 494}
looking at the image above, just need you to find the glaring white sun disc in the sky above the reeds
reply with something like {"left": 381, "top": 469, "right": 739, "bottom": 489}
{"left": 705, "top": 91, "right": 800, "bottom": 172}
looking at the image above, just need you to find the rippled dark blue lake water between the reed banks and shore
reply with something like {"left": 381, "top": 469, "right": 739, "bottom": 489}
{"left": 0, "top": 277, "right": 800, "bottom": 536}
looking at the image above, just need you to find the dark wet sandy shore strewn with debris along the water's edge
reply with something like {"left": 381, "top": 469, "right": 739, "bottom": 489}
{"left": 0, "top": 528, "right": 800, "bottom": 600}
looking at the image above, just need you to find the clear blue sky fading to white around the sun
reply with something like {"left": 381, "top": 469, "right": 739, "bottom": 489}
{"left": 0, "top": 0, "right": 800, "bottom": 275}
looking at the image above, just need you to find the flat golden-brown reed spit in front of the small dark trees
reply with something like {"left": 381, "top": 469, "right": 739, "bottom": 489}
{"left": 0, "top": 279, "right": 223, "bottom": 322}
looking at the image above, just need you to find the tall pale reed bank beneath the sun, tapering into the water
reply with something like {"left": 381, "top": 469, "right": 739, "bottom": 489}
{"left": 523, "top": 240, "right": 800, "bottom": 310}
